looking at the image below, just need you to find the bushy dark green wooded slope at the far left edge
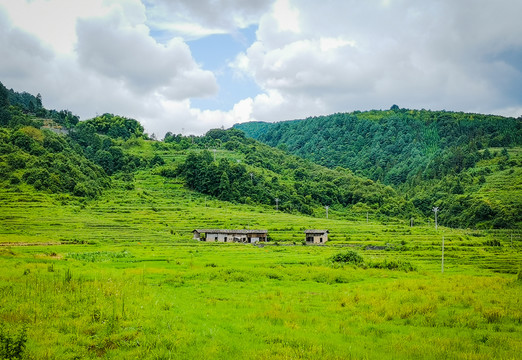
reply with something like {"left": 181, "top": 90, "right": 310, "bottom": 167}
{"left": 0, "top": 83, "right": 152, "bottom": 198}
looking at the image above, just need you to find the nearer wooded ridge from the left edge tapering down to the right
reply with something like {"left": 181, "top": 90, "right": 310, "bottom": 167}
{"left": 0, "top": 82, "right": 414, "bottom": 219}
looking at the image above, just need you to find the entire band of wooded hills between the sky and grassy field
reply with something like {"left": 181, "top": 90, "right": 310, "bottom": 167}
{"left": 0, "top": 83, "right": 522, "bottom": 228}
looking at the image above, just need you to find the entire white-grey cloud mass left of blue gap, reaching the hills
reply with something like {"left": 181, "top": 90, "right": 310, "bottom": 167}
{"left": 0, "top": 0, "right": 217, "bottom": 134}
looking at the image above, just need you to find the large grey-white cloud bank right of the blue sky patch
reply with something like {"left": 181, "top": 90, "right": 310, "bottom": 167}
{"left": 234, "top": 0, "right": 522, "bottom": 121}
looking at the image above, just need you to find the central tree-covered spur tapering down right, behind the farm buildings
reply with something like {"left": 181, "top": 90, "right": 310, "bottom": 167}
{"left": 173, "top": 129, "right": 416, "bottom": 216}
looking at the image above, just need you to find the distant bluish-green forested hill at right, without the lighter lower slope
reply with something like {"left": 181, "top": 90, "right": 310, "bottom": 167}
{"left": 235, "top": 106, "right": 522, "bottom": 185}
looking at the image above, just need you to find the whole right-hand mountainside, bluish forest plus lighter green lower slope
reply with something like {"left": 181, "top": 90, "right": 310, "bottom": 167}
{"left": 234, "top": 106, "right": 522, "bottom": 227}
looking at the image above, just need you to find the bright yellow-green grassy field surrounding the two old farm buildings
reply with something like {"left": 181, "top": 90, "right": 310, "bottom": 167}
{"left": 0, "top": 172, "right": 522, "bottom": 359}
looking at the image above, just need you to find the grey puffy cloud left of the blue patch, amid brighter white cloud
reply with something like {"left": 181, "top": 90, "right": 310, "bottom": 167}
{"left": 77, "top": 14, "right": 217, "bottom": 100}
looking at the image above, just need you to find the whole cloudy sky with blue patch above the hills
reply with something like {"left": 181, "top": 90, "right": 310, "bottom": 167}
{"left": 0, "top": 0, "right": 522, "bottom": 138}
